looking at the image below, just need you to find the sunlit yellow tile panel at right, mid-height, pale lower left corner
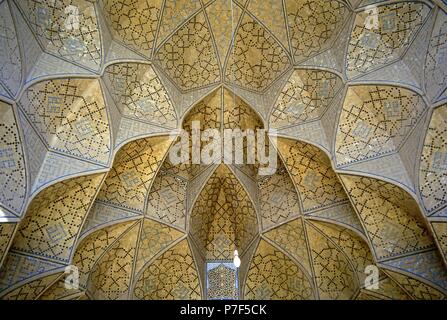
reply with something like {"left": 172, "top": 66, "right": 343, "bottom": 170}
{"left": 335, "top": 86, "right": 426, "bottom": 166}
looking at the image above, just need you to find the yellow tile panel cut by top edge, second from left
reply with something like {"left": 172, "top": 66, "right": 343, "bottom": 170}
{"left": 103, "top": 0, "right": 163, "bottom": 57}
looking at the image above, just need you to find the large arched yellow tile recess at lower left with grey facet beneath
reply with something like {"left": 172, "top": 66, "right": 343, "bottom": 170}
{"left": 0, "top": 174, "right": 104, "bottom": 294}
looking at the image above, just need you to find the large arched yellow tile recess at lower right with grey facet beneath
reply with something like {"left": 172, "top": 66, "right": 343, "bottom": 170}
{"left": 339, "top": 174, "right": 447, "bottom": 292}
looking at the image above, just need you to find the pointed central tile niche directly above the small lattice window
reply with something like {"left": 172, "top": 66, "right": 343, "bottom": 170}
{"left": 190, "top": 165, "right": 258, "bottom": 260}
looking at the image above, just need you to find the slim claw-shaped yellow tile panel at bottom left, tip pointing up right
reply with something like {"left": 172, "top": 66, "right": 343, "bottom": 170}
{"left": 88, "top": 223, "right": 140, "bottom": 300}
